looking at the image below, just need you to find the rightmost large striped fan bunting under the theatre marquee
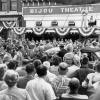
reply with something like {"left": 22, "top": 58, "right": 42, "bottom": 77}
{"left": 78, "top": 27, "right": 95, "bottom": 36}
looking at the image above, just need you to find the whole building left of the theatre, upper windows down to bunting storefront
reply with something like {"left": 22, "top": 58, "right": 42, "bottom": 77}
{"left": 0, "top": 0, "right": 25, "bottom": 38}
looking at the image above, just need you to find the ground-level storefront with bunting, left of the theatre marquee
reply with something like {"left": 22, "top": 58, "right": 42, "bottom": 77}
{"left": 0, "top": 12, "right": 23, "bottom": 39}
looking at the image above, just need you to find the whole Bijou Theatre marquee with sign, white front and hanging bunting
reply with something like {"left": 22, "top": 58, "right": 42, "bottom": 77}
{"left": 22, "top": 4, "right": 100, "bottom": 37}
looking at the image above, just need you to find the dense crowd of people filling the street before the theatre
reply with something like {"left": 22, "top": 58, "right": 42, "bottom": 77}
{"left": 0, "top": 38, "right": 100, "bottom": 100}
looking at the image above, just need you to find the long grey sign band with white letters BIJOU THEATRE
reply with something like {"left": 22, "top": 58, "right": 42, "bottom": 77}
{"left": 23, "top": 4, "right": 100, "bottom": 15}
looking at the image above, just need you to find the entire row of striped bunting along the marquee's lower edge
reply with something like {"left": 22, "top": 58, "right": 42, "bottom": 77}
{"left": 0, "top": 27, "right": 100, "bottom": 37}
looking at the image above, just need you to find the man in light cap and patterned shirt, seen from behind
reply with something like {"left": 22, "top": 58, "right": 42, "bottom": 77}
{"left": 52, "top": 62, "right": 70, "bottom": 97}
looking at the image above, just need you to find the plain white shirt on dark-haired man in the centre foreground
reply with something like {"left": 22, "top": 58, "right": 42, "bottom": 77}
{"left": 26, "top": 77, "right": 56, "bottom": 100}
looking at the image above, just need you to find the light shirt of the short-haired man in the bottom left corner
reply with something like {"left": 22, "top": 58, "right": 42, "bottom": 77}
{"left": 0, "top": 86, "right": 31, "bottom": 100}
